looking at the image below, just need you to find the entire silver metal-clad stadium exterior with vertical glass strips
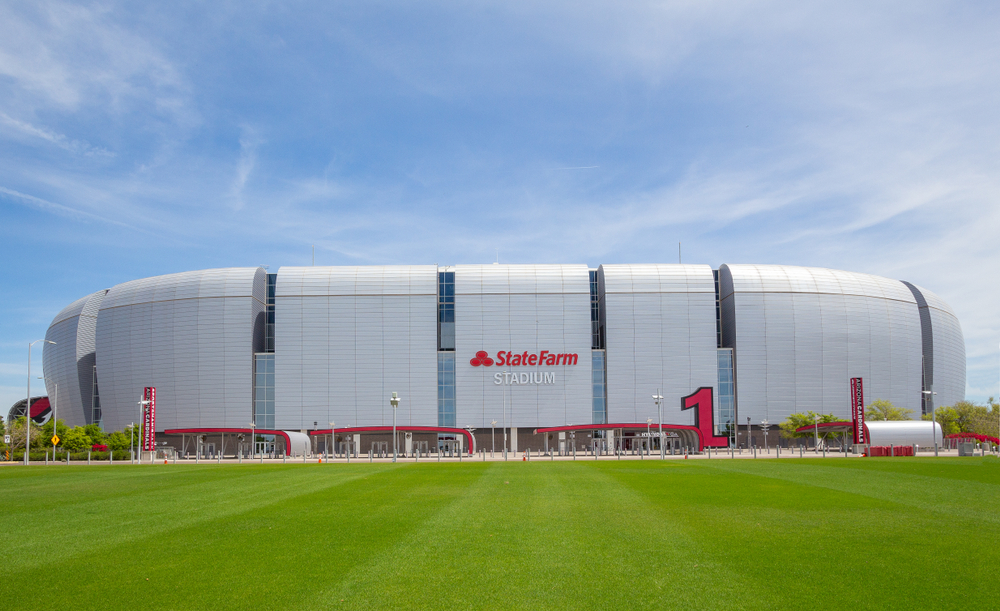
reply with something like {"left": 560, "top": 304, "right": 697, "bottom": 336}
{"left": 43, "top": 264, "right": 965, "bottom": 454}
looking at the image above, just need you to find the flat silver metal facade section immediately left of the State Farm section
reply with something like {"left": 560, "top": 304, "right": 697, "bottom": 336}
{"left": 275, "top": 265, "right": 437, "bottom": 429}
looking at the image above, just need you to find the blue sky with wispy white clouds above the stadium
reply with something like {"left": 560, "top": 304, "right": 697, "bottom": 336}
{"left": 0, "top": 0, "right": 1000, "bottom": 411}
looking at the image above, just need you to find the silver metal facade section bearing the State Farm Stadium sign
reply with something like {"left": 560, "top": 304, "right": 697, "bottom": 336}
{"left": 455, "top": 265, "right": 593, "bottom": 427}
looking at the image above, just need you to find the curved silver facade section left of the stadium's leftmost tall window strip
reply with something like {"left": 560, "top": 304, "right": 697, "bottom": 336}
{"left": 97, "top": 268, "right": 266, "bottom": 430}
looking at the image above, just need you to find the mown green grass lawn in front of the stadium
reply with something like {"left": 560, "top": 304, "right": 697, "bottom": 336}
{"left": 0, "top": 458, "right": 1000, "bottom": 610}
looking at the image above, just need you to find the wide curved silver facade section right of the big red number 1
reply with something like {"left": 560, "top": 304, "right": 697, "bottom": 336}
{"left": 720, "top": 265, "right": 920, "bottom": 423}
